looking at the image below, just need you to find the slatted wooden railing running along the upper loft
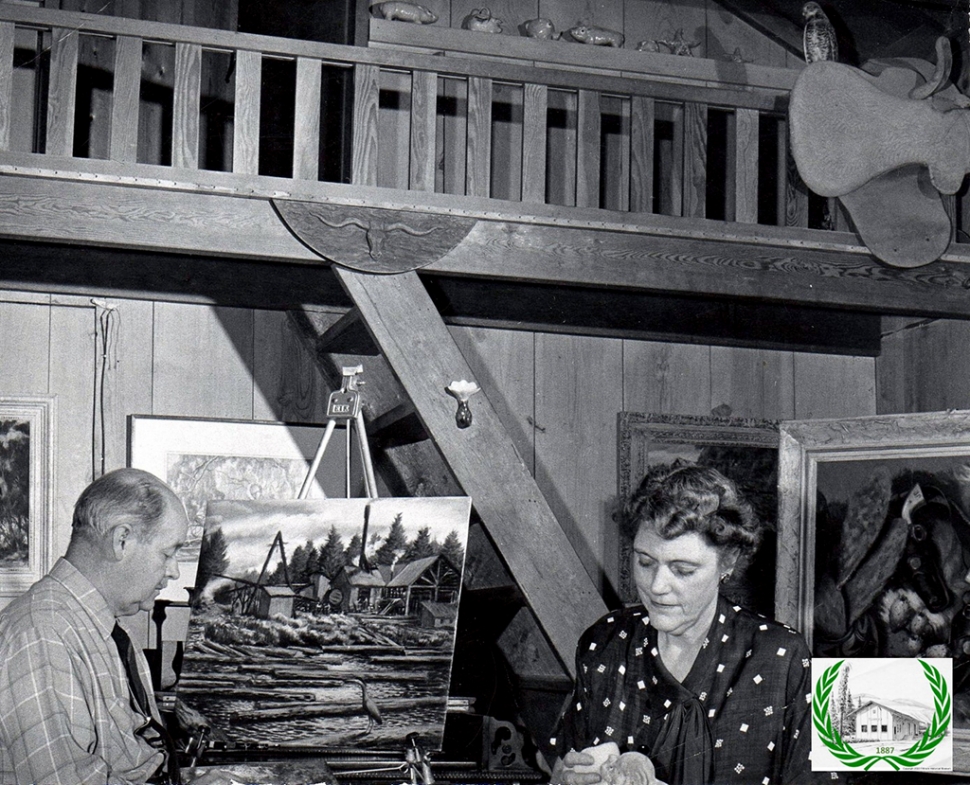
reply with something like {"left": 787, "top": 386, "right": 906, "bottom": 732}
{"left": 0, "top": 3, "right": 952, "bottom": 242}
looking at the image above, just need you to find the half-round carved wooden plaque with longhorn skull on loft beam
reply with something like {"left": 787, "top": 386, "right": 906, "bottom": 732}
{"left": 273, "top": 199, "right": 477, "bottom": 273}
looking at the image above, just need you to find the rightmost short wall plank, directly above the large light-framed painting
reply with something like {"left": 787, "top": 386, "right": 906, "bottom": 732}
{"left": 795, "top": 353, "right": 876, "bottom": 420}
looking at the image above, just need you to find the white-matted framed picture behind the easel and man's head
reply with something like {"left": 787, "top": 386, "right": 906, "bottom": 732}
{"left": 128, "top": 415, "right": 359, "bottom": 602}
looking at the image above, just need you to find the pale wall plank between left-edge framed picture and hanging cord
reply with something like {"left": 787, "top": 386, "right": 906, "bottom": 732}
{"left": 49, "top": 306, "right": 95, "bottom": 556}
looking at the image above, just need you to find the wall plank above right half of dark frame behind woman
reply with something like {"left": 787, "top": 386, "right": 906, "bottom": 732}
{"left": 711, "top": 346, "right": 795, "bottom": 420}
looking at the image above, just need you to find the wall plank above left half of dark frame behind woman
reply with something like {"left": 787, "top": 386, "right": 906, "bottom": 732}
{"left": 622, "top": 341, "right": 713, "bottom": 415}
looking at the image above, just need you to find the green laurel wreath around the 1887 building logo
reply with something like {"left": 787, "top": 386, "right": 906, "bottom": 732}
{"left": 812, "top": 660, "right": 950, "bottom": 771}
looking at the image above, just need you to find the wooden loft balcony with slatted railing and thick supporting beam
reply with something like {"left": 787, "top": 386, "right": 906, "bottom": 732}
{"left": 0, "top": 3, "right": 970, "bottom": 353}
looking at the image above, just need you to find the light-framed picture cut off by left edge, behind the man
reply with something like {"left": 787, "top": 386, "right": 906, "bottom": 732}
{"left": 0, "top": 396, "right": 54, "bottom": 602}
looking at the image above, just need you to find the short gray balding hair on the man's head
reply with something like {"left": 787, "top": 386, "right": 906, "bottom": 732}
{"left": 71, "top": 468, "right": 178, "bottom": 536}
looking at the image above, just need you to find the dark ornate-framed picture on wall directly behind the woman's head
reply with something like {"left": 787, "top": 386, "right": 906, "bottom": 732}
{"left": 615, "top": 412, "right": 778, "bottom": 615}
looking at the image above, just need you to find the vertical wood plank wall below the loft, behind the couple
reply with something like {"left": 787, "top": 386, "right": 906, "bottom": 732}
{"left": 0, "top": 292, "right": 875, "bottom": 608}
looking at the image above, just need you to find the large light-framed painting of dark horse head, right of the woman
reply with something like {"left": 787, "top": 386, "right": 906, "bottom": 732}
{"left": 776, "top": 411, "right": 970, "bottom": 756}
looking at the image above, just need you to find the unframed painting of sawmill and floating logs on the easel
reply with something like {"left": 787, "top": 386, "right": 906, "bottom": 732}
{"left": 177, "top": 497, "right": 471, "bottom": 749}
